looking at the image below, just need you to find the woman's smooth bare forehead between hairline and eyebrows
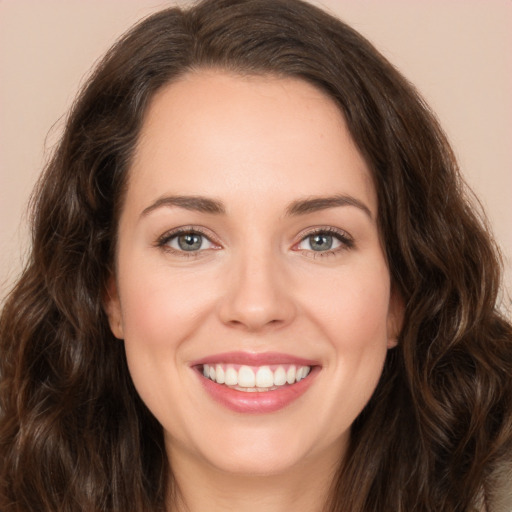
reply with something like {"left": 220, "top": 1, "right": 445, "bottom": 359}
{"left": 128, "top": 70, "right": 377, "bottom": 213}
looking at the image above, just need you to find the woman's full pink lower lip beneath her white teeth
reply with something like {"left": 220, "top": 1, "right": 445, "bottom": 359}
{"left": 197, "top": 366, "right": 320, "bottom": 414}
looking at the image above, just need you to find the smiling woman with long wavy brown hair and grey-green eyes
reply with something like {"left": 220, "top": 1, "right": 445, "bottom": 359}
{"left": 0, "top": 0, "right": 512, "bottom": 512}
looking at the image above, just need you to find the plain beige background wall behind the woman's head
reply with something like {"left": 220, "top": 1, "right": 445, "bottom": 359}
{"left": 0, "top": 0, "right": 512, "bottom": 308}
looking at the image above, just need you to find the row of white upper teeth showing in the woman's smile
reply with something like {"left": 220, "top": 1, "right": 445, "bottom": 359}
{"left": 203, "top": 364, "right": 311, "bottom": 391}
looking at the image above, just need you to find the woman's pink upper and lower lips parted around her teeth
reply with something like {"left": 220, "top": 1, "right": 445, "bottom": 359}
{"left": 191, "top": 352, "right": 321, "bottom": 414}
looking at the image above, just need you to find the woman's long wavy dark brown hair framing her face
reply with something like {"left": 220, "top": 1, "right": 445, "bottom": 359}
{"left": 0, "top": 0, "right": 512, "bottom": 512}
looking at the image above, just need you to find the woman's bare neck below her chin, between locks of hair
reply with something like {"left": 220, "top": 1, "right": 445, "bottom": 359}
{"left": 168, "top": 442, "right": 339, "bottom": 512}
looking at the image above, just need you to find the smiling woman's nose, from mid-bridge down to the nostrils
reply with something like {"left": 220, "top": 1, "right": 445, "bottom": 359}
{"left": 218, "top": 247, "right": 297, "bottom": 332}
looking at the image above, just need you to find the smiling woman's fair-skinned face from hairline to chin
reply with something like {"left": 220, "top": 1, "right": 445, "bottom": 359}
{"left": 107, "top": 71, "right": 400, "bottom": 474}
